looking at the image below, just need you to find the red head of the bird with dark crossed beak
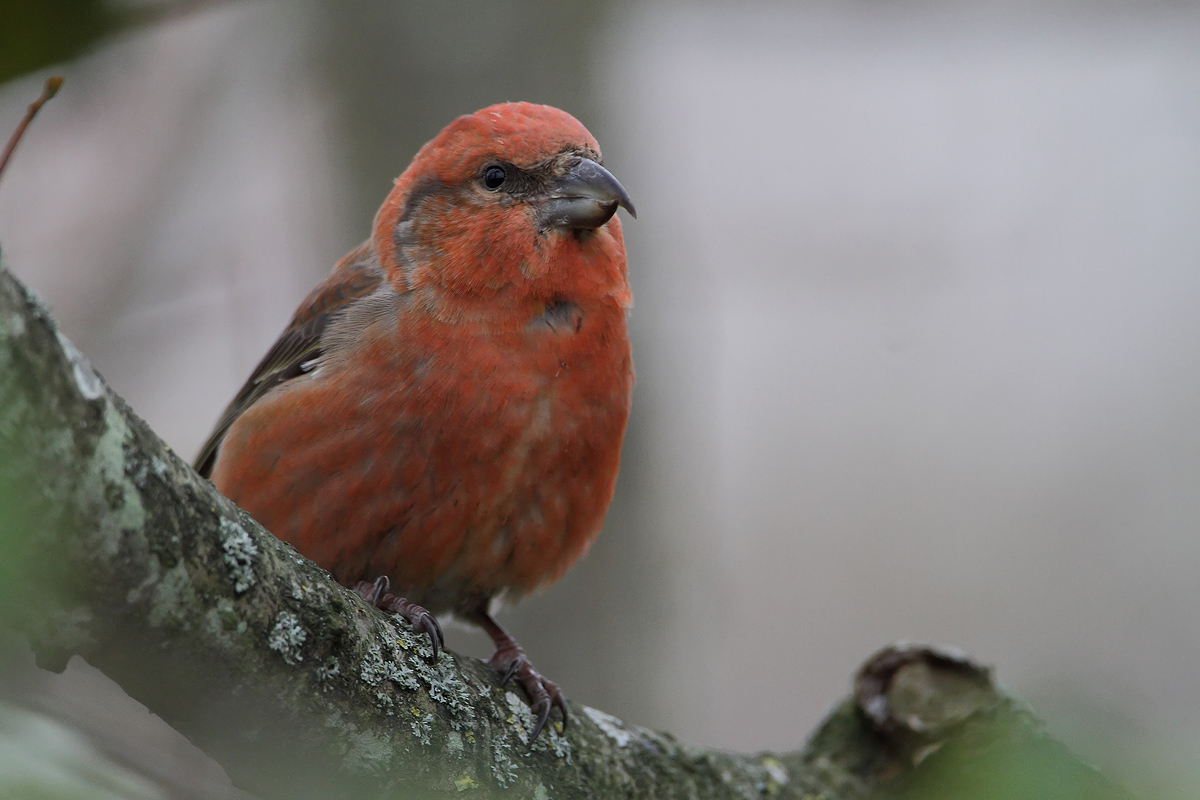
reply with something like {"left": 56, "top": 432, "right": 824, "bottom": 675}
{"left": 374, "top": 103, "right": 635, "bottom": 321}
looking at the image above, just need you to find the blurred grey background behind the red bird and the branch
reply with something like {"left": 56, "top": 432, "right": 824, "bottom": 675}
{"left": 0, "top": 0, "right": 1200, "bottom": 796}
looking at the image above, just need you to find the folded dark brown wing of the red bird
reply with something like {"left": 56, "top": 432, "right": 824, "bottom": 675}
{"left": 194, "top": 242, "right": 384, "bottom": 477}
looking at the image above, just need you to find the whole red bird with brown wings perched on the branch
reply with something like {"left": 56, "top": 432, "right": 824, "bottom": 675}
{"left": 196, "top": 103, "right": 635, "bottom": 740}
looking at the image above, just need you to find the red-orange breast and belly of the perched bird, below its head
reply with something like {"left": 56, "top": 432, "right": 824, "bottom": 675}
{"left": 222, "top": 300, "right": 634, "bottom": 613}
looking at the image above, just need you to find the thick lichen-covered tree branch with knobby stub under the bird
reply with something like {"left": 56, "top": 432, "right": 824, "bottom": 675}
{"left": 0, "top": 266, "right": 1126, "bottom": 800}
